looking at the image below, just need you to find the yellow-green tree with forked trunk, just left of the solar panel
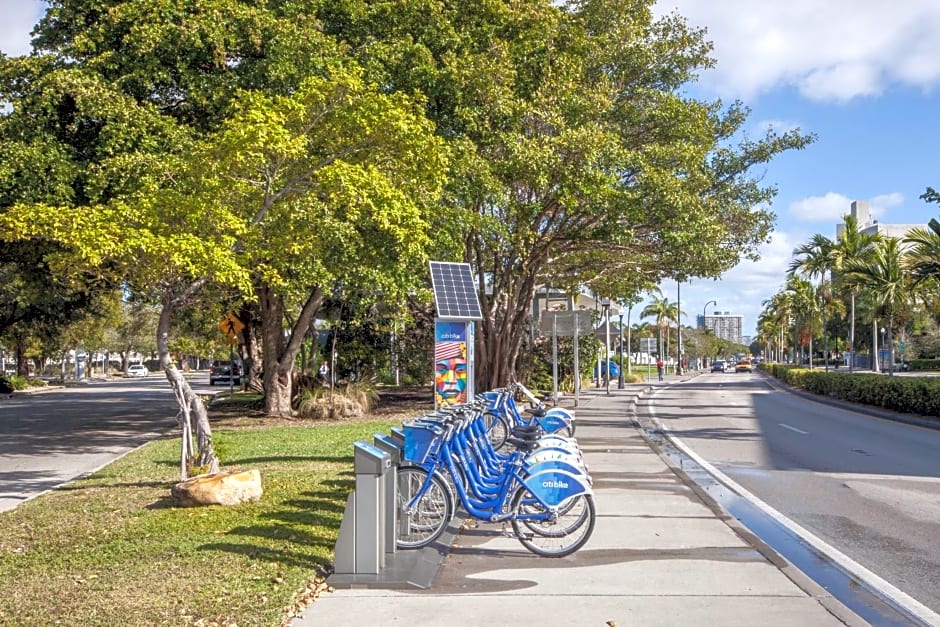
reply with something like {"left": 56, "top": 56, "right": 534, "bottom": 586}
{"left": 196, "top": 72, "right": 446, "bottom": 416}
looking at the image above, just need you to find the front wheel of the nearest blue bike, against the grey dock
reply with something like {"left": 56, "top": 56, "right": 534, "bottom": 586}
{"left": 395, "top": 466, "right": 454, "bottom": 549}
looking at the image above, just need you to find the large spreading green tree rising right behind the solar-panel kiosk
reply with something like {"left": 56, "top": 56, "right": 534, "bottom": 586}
{"left": 312, "top": 0, "right": 811, "bottom": 387}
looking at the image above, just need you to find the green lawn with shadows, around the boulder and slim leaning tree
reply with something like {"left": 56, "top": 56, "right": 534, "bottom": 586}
{"left": 0, "top": 420, "right": 400, "bottom": 627}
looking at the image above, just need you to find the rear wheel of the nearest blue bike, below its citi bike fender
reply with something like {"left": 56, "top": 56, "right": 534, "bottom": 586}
{"left": 512, "top": 488, "right": 595, "bottom": 557}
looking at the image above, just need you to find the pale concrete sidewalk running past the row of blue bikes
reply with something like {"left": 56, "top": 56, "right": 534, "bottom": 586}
{"left": 293, "top": 375, "right": 866, "bottom": 627}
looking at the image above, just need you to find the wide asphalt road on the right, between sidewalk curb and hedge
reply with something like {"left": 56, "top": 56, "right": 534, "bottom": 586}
{"left": 655, "top": 373, "right": 940, "bottom": 611}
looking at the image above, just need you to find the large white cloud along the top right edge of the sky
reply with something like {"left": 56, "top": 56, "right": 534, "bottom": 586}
{"left": 657, "top": 0, "right": 940, "bottom": 102}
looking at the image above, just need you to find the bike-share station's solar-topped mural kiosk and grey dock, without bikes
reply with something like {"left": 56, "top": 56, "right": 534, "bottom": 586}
{"left": 327, "top": 261, "right": 483, "bottom": 588}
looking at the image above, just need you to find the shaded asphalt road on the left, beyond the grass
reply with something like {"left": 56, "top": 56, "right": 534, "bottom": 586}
{"left": 0, "top": 373, "right": 209, "bottom": 511}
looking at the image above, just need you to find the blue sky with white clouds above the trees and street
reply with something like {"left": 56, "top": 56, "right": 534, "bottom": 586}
{"left": 0, "top": 0, "right": 940, "bottom": 335}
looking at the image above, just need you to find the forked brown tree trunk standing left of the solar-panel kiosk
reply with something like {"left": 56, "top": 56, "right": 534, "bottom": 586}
{"left": 257, "top": 286, "right": 323, "bottom": 418}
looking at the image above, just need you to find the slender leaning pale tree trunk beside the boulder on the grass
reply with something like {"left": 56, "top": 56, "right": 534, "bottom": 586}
{"left": 157, "top": 282, "right": 219, "bottom": 480}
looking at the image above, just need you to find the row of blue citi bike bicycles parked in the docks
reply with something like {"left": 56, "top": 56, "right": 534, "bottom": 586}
{"left": 397, "top": 383, "right": 595, "bottom": 557}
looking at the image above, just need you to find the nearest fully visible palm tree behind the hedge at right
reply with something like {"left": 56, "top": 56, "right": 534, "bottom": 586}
{"left": 844, "top": 237, "right": 911, "bottom": 374}
